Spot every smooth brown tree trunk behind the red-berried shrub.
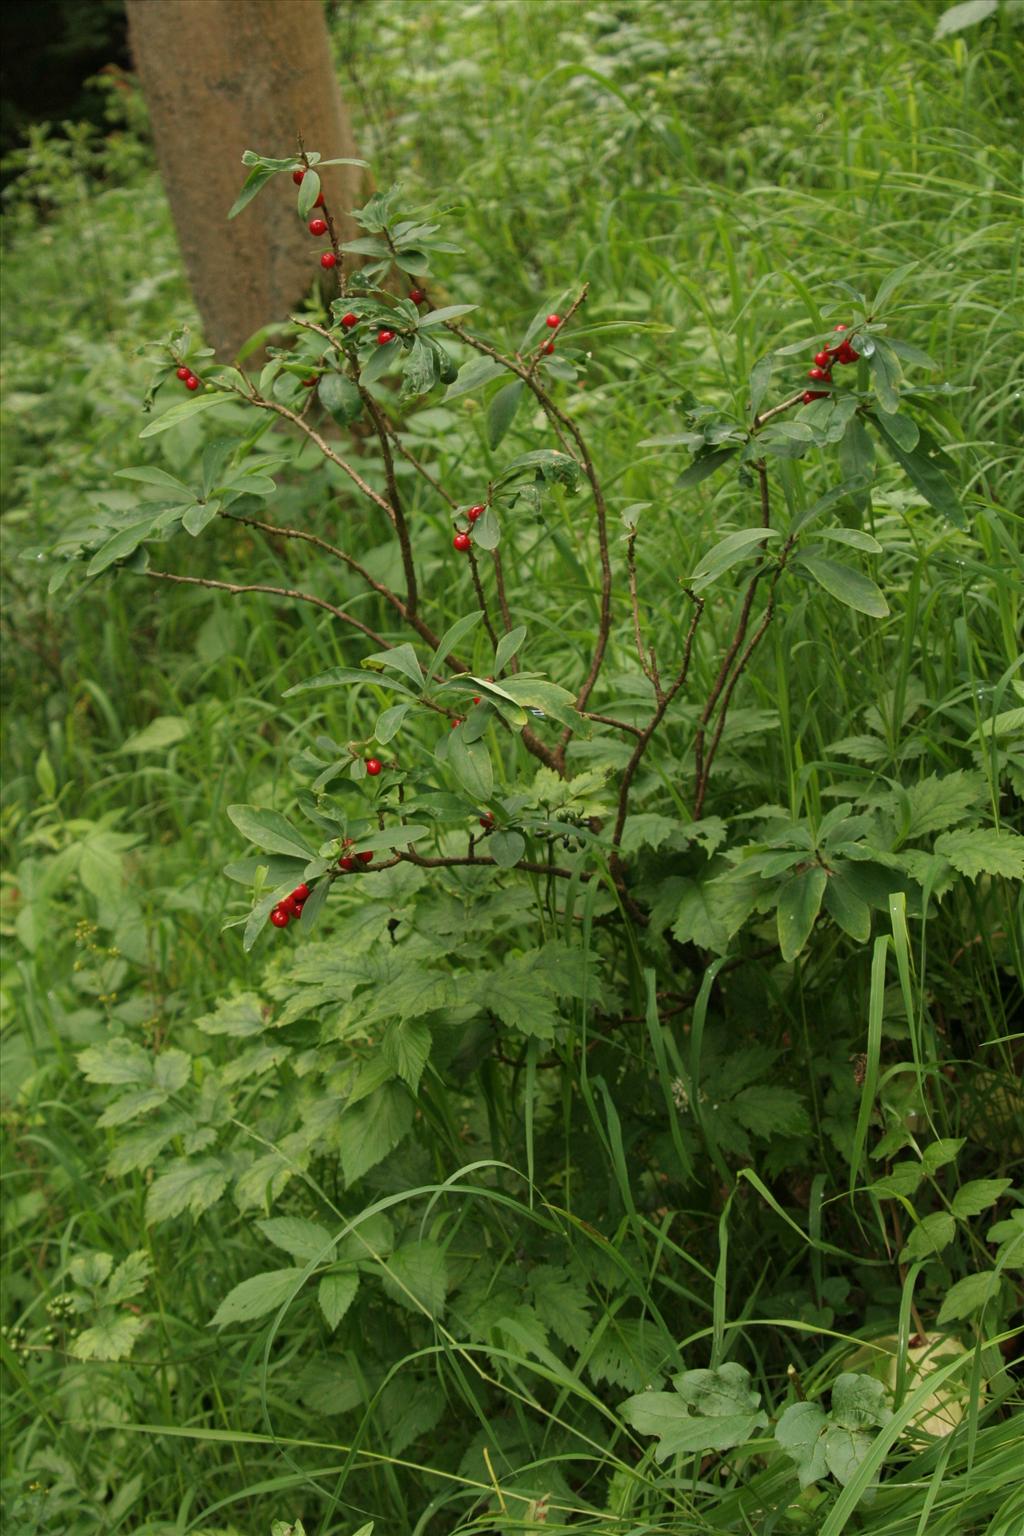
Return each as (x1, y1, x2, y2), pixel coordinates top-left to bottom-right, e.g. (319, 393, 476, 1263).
(127, 0, 364, 361)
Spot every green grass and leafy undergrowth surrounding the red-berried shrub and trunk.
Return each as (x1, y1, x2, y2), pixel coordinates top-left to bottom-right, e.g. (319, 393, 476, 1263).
(0, 0, 1024, 1536)
